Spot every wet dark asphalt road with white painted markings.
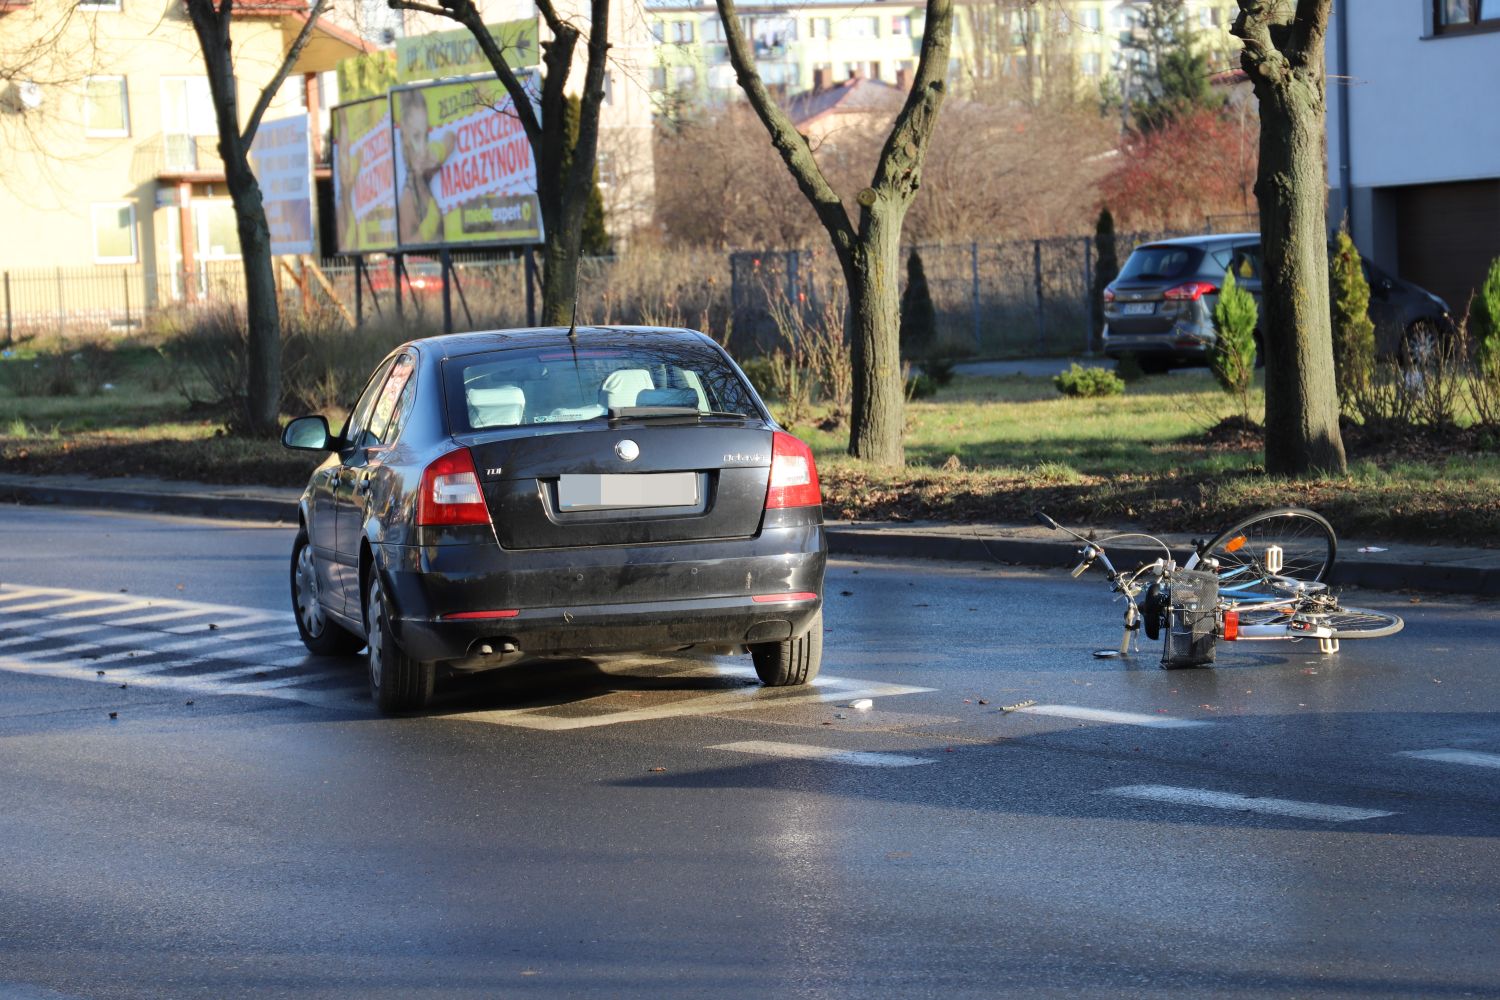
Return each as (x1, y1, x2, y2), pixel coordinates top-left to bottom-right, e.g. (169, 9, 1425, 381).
(0, 507, 1500, 1000)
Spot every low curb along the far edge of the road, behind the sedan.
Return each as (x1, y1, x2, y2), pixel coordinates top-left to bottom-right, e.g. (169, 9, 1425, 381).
(0, 477, 1500, 597)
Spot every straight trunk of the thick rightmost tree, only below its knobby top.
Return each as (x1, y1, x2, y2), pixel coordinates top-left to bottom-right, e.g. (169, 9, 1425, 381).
(1256, 76, 1344, 475)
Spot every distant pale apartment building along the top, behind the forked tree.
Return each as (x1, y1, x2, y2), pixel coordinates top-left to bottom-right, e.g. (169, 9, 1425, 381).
(645, 0, 1236, 115)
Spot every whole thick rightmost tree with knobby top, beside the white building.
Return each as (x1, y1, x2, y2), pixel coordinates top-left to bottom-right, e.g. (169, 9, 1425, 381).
(1233, 0, 1346, 475)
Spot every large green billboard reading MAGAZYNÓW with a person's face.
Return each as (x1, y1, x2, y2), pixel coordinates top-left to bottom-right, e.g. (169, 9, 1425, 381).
(390, 72, 542, 249)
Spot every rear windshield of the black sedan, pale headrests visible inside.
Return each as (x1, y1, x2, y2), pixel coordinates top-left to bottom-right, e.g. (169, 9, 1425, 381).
(444, 340, 761, 433)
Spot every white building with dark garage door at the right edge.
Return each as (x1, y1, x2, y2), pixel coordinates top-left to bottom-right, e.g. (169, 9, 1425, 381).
(1328, 0, 1500, 313)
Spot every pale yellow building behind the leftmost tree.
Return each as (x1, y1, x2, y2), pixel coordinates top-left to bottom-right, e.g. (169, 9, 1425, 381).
(0, 0, 365, 333)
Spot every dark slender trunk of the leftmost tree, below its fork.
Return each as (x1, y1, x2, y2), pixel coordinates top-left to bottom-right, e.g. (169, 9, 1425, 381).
(224, 154, 281, 436)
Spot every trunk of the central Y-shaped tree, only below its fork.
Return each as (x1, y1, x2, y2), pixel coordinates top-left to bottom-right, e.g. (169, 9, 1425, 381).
(843, 202, 906, 466)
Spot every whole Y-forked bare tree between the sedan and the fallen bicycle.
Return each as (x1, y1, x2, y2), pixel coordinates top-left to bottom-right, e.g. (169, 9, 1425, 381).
(717, 0, 953, 466)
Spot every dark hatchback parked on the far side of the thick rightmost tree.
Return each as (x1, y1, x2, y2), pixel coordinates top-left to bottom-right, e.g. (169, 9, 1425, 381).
(1104, 232, 1454, 372)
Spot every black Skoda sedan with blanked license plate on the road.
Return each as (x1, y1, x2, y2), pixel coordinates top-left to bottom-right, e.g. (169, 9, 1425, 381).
(282, 327, 828, 712)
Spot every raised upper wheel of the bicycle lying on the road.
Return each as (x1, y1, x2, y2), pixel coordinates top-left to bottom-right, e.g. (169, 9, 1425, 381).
(1196, 507, 1338, 587)
